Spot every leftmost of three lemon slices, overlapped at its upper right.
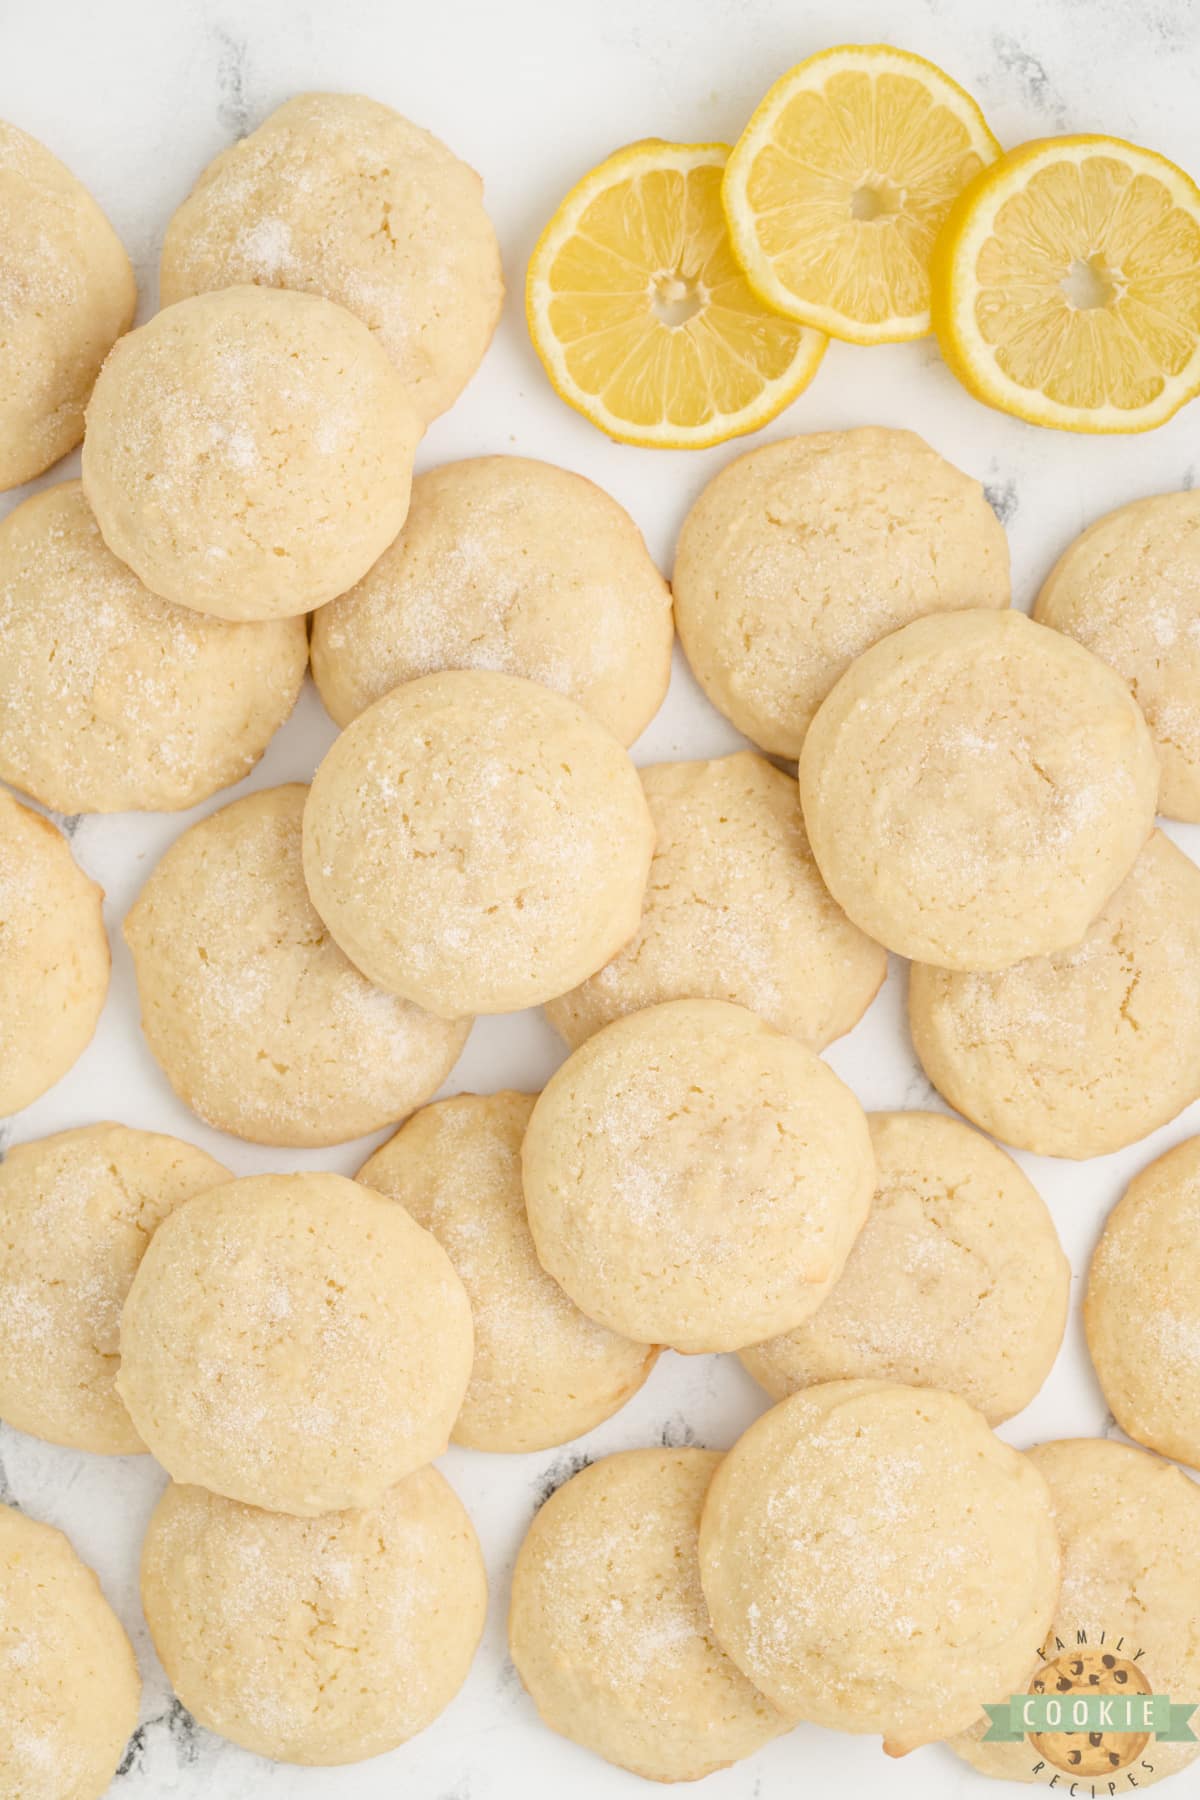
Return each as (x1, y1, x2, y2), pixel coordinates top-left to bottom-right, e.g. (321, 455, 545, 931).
(525, 140, 826, 450)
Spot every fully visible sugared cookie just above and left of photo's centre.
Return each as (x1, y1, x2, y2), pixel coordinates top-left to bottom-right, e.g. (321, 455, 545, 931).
(304, 670, 655, 1019)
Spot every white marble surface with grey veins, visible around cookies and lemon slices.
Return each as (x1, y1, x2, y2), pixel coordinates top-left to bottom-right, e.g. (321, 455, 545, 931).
(0, 0, 1200, 1800)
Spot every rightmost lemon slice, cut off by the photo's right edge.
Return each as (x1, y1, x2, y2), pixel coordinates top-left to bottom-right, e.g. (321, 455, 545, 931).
(934, 137, 1200, 432)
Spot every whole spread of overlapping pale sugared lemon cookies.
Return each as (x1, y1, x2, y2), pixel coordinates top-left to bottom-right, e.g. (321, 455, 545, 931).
(0, 81, 1200, 1800)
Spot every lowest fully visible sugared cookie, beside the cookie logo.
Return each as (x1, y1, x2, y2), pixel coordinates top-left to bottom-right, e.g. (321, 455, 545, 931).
(700, 1381, 1061, 1755)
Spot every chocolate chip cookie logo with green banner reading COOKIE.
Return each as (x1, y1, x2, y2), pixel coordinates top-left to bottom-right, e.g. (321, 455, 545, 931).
(984, 1631, 1198, 1796)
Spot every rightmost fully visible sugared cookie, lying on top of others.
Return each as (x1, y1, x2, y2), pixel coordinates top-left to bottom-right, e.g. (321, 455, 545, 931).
(801, 612, 1159, 968)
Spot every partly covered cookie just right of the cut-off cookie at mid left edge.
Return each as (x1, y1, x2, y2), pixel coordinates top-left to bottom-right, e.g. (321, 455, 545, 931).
(124, 783, 471, 1145)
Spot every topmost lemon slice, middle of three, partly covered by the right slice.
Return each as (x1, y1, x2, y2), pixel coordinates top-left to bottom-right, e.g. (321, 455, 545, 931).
(723, 43, 1000, 344)
